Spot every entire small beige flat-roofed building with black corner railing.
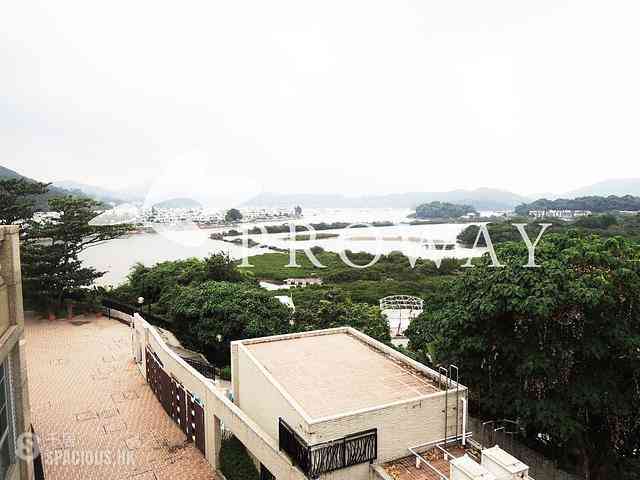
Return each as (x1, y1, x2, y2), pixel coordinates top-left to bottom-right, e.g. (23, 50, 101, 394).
(231, 328, 467, 479)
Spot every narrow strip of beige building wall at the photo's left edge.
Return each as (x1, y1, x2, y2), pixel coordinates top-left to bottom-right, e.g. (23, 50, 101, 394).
(0, 226, 33, 480)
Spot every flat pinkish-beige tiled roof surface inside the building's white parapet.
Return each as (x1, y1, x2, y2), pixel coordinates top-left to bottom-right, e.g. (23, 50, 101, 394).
(245, 332, 439, 420)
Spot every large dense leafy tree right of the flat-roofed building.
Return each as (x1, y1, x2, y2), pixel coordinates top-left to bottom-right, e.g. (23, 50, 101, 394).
(408, 232, 640, 480)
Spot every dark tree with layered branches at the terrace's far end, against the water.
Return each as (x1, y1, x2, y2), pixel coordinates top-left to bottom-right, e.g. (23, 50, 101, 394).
(22, 197, 130, 310)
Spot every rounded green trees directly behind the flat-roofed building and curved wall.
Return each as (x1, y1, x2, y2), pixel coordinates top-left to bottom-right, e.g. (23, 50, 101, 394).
(110, 253, 398, 366)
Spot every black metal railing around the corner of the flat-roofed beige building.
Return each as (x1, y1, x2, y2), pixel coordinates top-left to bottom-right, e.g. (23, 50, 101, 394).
(278, 419, 378, 478)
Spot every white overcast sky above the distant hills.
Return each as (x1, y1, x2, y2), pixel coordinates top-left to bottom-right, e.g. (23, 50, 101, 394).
(0, 0, 640, 194)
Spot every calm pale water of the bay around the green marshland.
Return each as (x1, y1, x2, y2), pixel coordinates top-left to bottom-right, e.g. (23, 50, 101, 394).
(82, 209, 484, 285)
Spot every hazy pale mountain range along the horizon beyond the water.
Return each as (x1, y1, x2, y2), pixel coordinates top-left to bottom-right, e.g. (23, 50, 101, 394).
(0, 163, 640, 211)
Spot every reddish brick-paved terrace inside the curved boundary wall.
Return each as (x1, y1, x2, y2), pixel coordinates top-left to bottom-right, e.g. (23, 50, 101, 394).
(26, 317, 216, 480)
